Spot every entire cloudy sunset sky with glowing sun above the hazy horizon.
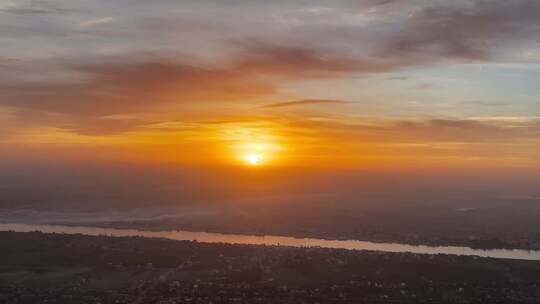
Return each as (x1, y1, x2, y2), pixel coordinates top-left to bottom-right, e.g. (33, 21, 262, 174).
(0, 0, 540, 172)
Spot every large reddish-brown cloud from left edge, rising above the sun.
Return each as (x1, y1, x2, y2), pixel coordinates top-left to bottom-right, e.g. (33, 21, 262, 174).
(0, 43, 400, 115)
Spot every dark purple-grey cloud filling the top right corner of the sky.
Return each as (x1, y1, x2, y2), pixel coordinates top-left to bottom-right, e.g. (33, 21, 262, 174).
(383, 0, 540, 60)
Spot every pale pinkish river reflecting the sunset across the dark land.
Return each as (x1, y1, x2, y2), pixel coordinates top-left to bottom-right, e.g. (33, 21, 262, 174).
(0, 224, 540, 260)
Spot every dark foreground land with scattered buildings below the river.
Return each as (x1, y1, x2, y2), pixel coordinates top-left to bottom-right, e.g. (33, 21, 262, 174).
(0, 232, 540, 304)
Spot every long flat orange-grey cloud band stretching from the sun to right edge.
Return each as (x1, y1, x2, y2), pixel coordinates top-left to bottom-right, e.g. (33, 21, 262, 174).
(287, 117, 540, 144)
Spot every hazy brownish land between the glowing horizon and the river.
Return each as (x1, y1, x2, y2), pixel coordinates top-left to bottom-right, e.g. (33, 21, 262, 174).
(0, 164, 540, 248)
